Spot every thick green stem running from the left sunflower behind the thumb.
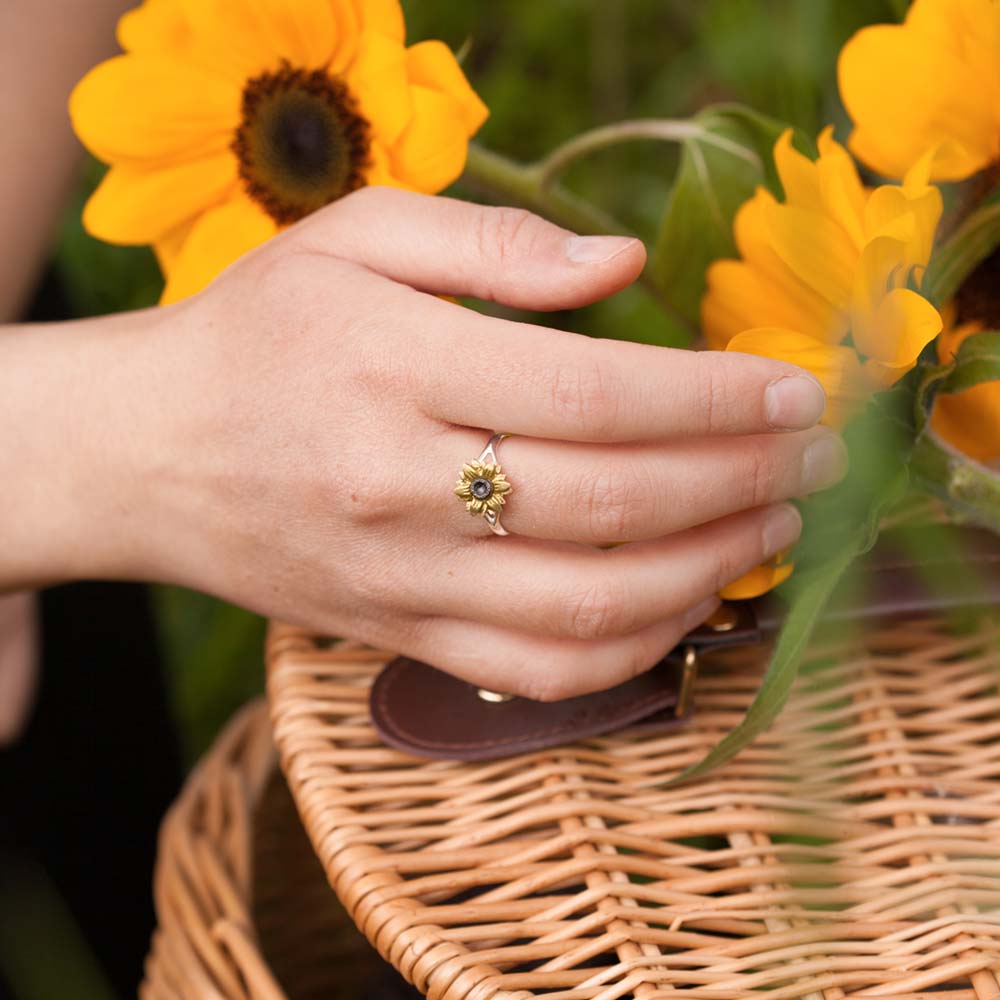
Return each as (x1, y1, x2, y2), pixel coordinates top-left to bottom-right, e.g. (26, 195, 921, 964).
(464, 143, 687, 318)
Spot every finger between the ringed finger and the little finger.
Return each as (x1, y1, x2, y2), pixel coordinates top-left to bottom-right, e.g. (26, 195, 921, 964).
(398, 504, 802, 640)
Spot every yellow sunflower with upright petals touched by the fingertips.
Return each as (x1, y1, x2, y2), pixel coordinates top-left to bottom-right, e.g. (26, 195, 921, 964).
(702, 129, 942, 599)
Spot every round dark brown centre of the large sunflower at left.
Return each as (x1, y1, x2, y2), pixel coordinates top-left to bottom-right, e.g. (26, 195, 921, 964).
(232, 63, 370, 225)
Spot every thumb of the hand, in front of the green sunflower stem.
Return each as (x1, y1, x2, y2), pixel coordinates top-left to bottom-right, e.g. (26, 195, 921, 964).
(296, 187, 646, 309)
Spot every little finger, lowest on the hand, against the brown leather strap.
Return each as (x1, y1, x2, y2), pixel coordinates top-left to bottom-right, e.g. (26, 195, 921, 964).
(406, 600, 719, 701)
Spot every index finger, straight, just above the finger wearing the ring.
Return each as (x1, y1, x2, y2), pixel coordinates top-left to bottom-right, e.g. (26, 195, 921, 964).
(428, 302, 826, 442)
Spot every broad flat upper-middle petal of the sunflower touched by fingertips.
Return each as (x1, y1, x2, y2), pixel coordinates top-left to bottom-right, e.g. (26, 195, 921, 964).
(764, 205, 858, 306)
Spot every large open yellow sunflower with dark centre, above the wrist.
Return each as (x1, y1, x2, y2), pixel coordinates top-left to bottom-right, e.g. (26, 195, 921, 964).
(70, 0, 488, 302)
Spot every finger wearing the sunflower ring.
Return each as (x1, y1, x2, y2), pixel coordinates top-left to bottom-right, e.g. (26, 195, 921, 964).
(446, 427, 847, 545)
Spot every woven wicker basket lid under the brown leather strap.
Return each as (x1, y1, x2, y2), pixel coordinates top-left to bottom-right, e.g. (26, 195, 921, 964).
(269, 621, 1000, 1000)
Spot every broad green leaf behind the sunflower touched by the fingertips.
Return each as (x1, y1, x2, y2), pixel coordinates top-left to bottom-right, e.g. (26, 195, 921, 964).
(652, 105, 808, 324)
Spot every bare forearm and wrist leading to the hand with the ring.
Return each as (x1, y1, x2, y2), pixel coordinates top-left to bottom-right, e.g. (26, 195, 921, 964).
(0, 313, 164, 592)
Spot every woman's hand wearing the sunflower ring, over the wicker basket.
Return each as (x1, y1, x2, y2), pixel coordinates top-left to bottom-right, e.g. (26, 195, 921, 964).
(1, 189, 845, 699)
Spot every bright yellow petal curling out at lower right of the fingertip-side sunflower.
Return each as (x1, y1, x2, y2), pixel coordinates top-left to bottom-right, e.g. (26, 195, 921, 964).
(854, 288, 943, 386)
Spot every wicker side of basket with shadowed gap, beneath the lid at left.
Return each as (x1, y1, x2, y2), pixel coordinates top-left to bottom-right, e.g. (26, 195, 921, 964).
(140, 701, 380, 1000)
